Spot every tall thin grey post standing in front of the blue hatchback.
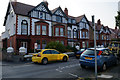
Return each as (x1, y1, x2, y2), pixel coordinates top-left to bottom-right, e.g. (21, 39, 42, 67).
(92, 15, 97, 80)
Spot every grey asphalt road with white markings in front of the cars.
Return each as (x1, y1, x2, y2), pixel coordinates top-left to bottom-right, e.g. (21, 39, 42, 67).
(2, 57, 120, 79)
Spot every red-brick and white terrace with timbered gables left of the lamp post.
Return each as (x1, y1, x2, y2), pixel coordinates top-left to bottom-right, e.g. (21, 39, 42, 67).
(2, 1, 109, 51)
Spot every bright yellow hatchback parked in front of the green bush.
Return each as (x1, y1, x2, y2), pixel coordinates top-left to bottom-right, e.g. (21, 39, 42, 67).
(32, 49, 69, 64)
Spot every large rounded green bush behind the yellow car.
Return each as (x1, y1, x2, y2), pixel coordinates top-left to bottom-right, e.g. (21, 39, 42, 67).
(45, 41, 66, 53)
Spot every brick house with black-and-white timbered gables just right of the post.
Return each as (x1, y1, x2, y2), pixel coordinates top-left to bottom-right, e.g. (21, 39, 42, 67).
(90, 19, 112, 47)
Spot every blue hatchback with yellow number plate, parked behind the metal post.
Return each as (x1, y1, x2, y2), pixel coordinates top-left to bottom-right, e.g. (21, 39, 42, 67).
(80, 48, 118, 71)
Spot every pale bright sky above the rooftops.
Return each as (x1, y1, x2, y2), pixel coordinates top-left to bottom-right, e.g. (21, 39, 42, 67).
(0, 0, 120, 35)
